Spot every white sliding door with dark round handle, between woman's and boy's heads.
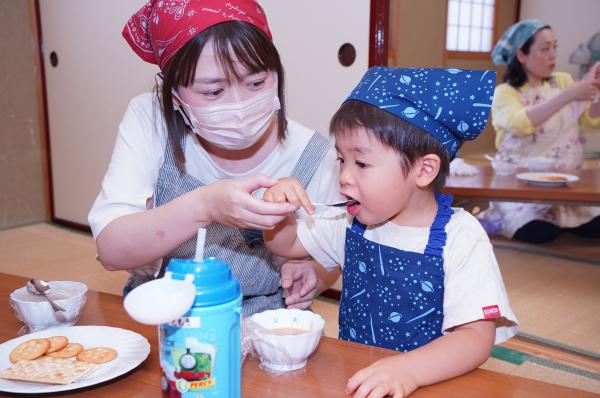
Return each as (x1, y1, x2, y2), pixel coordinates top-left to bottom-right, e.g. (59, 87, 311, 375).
(259, 0, 370, 136)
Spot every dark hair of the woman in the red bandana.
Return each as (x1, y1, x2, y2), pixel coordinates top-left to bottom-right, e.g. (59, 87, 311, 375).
(155, 21, 287, 172)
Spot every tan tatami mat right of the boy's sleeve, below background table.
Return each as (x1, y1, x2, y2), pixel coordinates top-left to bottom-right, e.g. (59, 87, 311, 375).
(495, 238, 600, 353)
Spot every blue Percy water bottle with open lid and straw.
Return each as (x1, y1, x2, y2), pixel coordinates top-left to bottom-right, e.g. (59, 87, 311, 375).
(159, 258, 242, 398)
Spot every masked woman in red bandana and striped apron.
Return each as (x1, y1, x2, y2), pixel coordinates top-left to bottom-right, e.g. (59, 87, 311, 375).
(89, 0, 338, 315)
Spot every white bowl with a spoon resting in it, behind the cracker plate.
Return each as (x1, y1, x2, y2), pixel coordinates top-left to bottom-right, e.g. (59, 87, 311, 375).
(10, 281, 88, 332)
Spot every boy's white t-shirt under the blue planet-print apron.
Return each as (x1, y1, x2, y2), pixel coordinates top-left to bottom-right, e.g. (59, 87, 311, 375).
(298, 208, 518, 344)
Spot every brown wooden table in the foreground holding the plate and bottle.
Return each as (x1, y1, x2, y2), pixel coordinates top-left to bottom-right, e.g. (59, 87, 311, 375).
(0, 273, 598, 398)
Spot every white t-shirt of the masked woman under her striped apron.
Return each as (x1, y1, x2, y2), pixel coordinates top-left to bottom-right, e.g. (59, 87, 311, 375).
(88, 93, 339, 274)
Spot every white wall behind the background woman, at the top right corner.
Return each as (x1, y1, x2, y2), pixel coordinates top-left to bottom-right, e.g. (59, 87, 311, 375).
(520, 0, 600, 151)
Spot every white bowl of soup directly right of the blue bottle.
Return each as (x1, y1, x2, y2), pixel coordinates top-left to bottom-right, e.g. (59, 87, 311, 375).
(250, 308, 325, 372)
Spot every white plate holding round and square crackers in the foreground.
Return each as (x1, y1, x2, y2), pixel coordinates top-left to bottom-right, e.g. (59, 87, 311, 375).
(0, 326, 150, 394)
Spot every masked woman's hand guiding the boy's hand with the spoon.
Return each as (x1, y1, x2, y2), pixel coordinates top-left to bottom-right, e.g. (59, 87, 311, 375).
(198, 174, 296, 230)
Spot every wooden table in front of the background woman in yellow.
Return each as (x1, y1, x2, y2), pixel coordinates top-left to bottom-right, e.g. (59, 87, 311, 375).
(444, 162, 600, 205)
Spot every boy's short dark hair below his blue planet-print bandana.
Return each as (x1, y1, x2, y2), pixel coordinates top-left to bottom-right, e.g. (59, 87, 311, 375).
(329, 101, 450, 190)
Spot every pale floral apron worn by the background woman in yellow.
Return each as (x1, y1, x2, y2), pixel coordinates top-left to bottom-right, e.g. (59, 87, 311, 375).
(486, 79, 600, 238)
